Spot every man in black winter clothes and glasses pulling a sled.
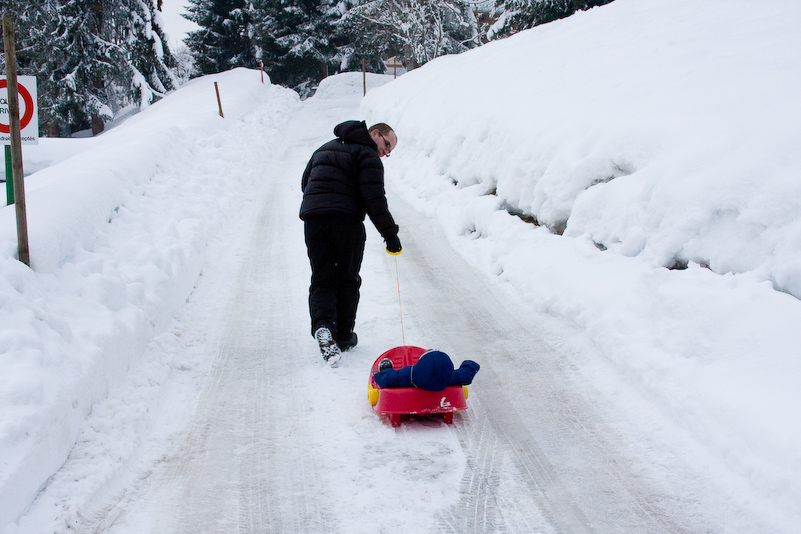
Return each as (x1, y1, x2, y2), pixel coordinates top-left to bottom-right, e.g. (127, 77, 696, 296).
(300, 121, 401, 365)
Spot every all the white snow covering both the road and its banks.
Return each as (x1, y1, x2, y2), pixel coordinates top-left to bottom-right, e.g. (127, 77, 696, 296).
(6, 0, 801, 534)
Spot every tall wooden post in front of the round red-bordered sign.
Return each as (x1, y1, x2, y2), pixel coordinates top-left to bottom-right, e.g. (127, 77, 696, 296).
(3, 16, 31, 267)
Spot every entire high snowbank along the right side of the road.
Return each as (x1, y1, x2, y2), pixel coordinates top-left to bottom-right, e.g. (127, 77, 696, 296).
(362, 0, 801, 528)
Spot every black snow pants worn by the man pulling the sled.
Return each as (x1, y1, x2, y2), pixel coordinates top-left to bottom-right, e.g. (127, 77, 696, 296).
(304, 216, 366, 341)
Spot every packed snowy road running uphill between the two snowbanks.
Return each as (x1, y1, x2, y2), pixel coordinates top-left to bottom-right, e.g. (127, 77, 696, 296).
(101, 90, 682, 533)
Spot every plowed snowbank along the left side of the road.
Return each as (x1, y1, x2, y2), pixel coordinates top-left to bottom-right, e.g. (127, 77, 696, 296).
(0, 69, 298, 526)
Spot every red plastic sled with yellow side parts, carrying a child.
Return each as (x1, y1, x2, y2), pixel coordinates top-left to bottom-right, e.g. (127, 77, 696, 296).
(367, 346, 467, 426)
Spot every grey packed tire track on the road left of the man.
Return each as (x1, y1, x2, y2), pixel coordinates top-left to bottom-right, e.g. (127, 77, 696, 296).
(162, 122, 335, 533)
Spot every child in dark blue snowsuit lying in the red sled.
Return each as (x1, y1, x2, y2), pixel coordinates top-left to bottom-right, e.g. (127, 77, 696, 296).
(373, 350, 481, 391)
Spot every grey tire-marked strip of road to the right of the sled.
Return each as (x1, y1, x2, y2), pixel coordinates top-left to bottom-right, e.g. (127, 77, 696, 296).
(384, 194, 687, 534)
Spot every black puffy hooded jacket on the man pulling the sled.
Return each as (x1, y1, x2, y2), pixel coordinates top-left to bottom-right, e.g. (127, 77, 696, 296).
(300, 121, 398, 239)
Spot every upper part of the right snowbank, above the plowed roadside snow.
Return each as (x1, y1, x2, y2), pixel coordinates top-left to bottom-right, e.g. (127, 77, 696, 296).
(368, 0, 801, 297)
